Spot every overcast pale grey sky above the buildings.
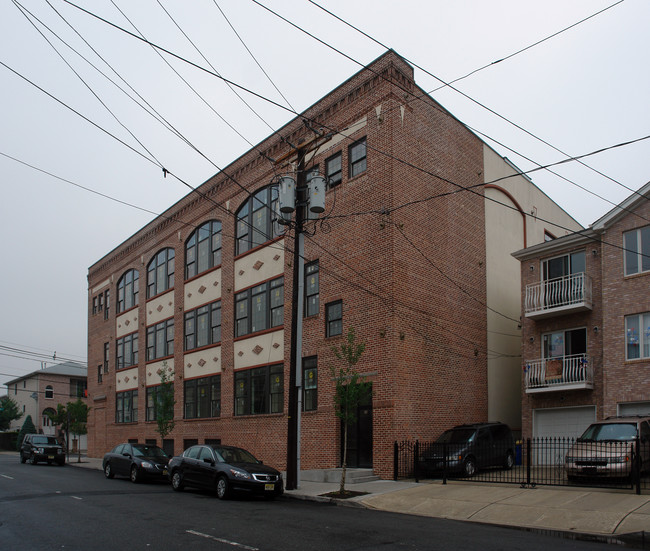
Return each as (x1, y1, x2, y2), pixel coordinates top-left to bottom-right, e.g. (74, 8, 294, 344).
(0, 0, 650, 394)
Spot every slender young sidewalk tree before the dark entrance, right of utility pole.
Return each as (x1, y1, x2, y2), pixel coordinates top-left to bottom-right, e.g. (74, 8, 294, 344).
(332, 327, 372, 496)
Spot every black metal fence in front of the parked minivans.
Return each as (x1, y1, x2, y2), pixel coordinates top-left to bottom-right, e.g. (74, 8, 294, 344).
(393, 438, 650, 493)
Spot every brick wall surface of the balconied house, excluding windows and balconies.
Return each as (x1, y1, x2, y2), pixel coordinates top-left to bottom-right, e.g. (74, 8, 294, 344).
(515, 186, 650, 437)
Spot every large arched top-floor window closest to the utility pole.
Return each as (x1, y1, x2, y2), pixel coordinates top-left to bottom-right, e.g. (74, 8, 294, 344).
(235, 185, 281, 254)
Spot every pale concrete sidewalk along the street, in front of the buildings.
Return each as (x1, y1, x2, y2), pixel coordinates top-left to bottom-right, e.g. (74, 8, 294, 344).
(63, 456, 650, 545)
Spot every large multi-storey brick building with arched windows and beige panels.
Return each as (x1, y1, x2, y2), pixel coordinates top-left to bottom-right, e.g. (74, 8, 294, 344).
(88, 51, 580, 477)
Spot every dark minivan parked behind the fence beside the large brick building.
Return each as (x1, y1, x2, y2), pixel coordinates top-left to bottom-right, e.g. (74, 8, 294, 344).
(420, 423, 515, 477)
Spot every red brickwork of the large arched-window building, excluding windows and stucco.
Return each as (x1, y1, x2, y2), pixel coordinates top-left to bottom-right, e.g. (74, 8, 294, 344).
(88, 52, 512, 477)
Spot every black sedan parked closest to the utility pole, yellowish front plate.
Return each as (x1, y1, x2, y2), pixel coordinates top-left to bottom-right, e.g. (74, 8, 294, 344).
(168, 444, 284, 499)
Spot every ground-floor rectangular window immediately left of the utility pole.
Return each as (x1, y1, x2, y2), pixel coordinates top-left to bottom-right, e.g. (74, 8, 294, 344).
(235, 364, 284, 415)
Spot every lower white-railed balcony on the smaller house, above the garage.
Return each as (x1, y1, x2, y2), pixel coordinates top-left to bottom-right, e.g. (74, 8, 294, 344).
(524, 354, 594, 394)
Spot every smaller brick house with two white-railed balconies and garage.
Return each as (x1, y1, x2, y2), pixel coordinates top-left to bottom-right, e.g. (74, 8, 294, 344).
(514, 184, 650, 437)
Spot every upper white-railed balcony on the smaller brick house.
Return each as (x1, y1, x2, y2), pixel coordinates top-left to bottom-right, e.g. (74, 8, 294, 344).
(524, 272, 593, 319)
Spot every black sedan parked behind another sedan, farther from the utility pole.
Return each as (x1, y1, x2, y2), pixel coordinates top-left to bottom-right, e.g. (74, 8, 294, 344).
(102, 444, 169, 482)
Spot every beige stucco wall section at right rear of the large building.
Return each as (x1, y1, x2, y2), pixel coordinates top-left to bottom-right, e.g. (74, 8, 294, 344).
(484, 146, 581, 429)
